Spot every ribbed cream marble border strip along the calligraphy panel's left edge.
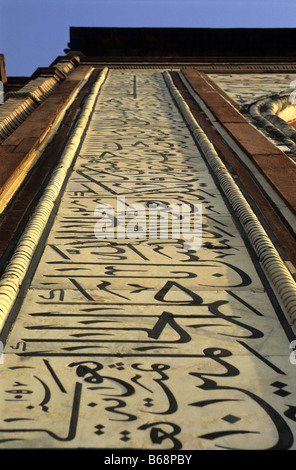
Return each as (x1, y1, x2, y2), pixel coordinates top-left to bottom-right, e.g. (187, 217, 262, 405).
(0, 68, 108, 331)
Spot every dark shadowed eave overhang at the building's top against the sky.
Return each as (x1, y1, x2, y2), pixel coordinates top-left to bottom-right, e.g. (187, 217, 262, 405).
(67, 27, 296, 63)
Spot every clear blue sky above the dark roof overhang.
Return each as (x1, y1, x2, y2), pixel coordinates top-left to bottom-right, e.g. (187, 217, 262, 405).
(0, 0, 296, 76)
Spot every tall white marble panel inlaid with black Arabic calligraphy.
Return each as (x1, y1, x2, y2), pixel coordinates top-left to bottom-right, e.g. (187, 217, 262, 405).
(0, 69, 296, 450)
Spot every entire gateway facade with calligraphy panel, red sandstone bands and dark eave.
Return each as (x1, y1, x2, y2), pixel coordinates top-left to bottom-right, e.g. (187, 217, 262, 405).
(0, 28, 296, 451)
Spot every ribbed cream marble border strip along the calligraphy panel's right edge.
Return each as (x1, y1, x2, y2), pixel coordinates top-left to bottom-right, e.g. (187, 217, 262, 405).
(164, 72, 296, 327)
